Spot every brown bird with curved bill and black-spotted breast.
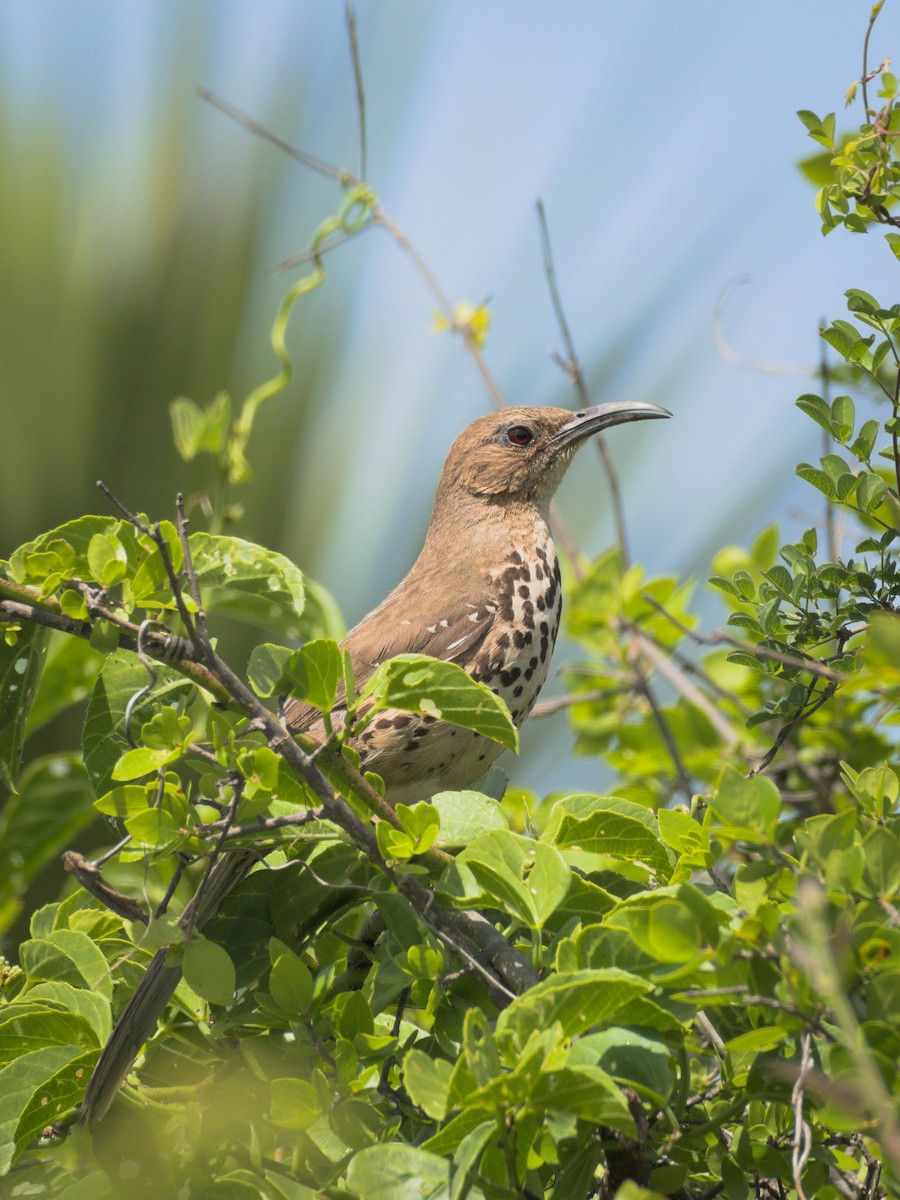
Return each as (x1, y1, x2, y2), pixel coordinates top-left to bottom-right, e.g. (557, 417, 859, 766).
(79, 401, 671, 1126)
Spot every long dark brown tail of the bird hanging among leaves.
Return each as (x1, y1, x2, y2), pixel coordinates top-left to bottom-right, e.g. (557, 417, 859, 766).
(78, 851, 259, 1126)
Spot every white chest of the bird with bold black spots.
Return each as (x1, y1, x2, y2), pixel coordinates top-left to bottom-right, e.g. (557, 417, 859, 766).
(469, 539, 563, 725)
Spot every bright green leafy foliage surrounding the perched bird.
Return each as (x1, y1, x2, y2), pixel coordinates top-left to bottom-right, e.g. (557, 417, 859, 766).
(0, 5, 900, 1200)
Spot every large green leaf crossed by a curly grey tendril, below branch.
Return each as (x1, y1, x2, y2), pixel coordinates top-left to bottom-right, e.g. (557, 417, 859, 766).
(82, 650, 194, 796)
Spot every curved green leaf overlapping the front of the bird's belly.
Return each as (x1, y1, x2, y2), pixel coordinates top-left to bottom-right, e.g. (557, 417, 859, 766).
(362, 654, 518, 751)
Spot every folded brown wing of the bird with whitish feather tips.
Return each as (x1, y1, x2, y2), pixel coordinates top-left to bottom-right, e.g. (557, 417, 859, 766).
(284, 596, 497, 734)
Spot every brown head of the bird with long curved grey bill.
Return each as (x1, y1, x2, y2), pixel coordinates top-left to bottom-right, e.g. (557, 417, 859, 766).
(436, 401, 671, 511)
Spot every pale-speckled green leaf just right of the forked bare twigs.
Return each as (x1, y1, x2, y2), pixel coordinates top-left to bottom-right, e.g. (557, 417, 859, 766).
(188, 533, 304, 637)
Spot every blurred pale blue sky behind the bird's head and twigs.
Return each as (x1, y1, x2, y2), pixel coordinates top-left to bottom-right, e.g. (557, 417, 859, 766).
(0, 7, 899, 796)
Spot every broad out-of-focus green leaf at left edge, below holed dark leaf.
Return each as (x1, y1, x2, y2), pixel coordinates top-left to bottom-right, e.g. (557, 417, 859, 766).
(0, 754, 94, 931)
